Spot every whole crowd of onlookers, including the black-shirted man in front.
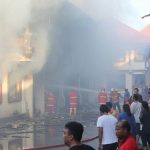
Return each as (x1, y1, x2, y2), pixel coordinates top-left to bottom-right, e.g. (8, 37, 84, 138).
(63, 88, 150, 150)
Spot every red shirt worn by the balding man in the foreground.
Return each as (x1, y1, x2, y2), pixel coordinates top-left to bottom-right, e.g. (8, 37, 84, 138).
(119, 135, 138, 150)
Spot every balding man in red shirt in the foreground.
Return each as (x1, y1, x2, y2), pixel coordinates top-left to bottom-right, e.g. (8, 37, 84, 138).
(116, 120, 138, 150)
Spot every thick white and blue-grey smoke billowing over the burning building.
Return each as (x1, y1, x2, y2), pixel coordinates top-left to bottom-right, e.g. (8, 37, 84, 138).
(0, 0, 149, 89)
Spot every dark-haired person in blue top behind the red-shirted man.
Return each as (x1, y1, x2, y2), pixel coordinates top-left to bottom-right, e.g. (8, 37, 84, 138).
(118, 104, 136, 137)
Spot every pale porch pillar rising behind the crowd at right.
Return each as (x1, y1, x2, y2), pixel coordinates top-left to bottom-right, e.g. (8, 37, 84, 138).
(125, 73, 133, 93)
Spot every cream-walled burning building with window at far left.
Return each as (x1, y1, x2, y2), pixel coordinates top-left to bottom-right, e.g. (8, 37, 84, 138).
(0, 27, 33, 118)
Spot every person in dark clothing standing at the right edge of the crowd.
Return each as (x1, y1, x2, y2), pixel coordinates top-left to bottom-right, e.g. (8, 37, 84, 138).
(140, 101, 150, 150)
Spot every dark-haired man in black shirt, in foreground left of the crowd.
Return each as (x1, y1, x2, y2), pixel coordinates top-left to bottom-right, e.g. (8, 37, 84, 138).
(63, 121, 95, 150)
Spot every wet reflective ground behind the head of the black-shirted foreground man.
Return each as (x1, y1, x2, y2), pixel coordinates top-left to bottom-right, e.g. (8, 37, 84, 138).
(0, 116, 97, 150)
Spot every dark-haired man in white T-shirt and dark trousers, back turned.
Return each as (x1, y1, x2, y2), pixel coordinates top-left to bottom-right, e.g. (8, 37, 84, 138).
(97, 105, 118, 150)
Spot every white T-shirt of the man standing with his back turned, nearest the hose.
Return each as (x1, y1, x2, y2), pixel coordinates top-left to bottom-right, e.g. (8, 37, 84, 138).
(97, 115, 117, 145)
